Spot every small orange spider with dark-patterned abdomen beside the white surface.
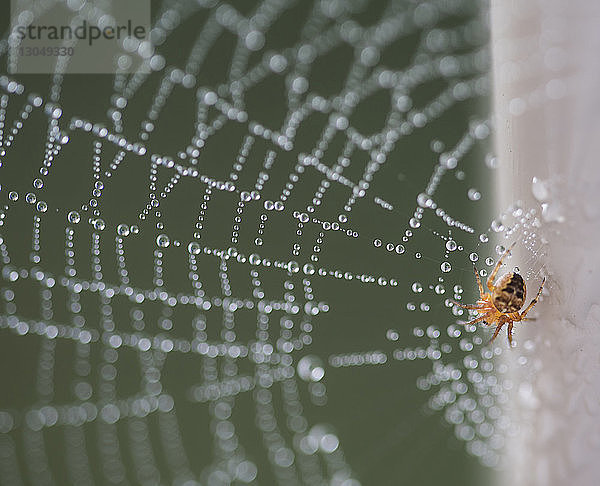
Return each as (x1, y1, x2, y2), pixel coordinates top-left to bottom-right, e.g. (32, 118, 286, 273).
(454, 242, 546, 346)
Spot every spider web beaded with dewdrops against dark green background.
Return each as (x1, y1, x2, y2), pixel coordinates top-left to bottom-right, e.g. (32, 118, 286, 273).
(0, 0, 536, 486)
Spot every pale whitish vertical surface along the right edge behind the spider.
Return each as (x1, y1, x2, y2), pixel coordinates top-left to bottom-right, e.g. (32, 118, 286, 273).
(492, 0, 600, 486)
